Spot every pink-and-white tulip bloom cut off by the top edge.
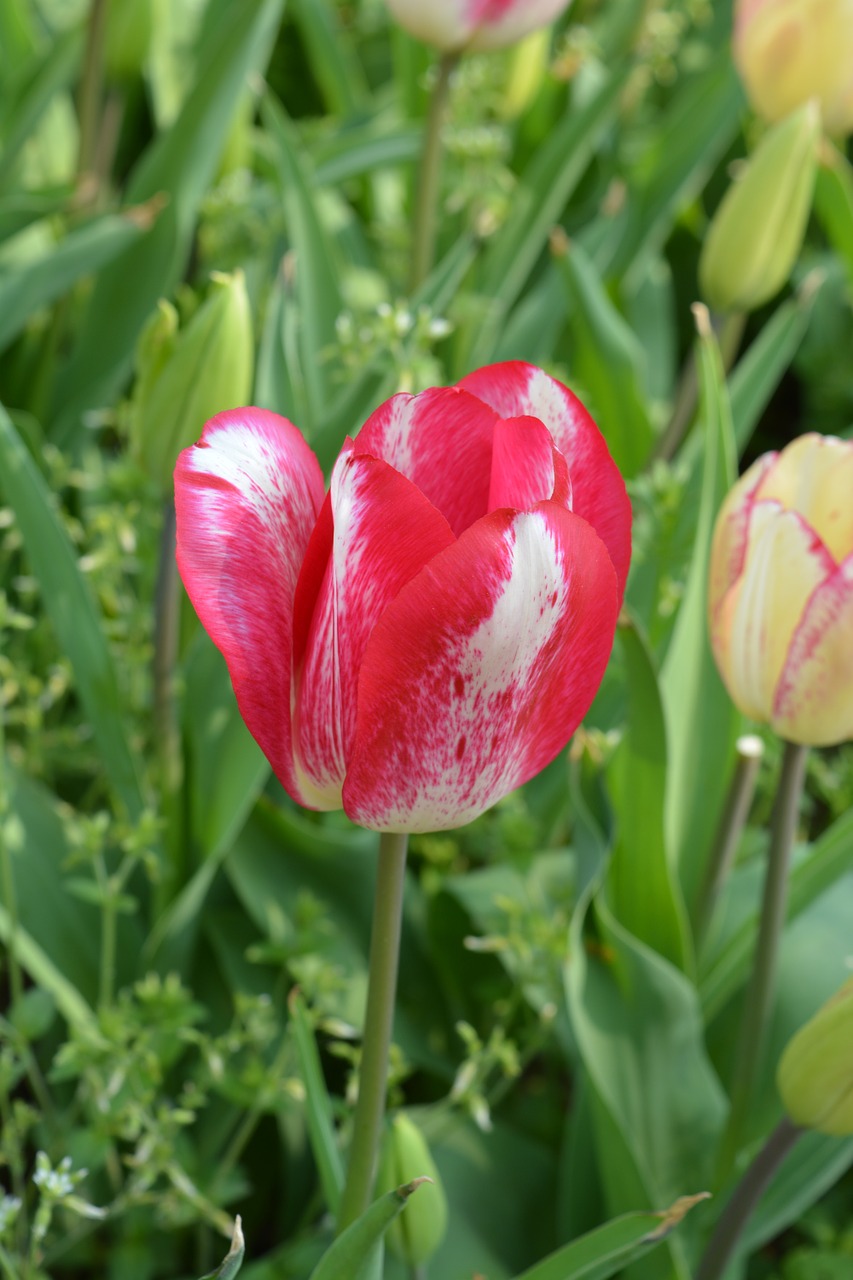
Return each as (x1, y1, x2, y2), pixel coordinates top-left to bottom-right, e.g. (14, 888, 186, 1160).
(388, 0, 570, 52)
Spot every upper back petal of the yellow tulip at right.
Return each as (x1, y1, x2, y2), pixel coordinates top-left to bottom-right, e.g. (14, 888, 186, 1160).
(756, 431, 853, 563)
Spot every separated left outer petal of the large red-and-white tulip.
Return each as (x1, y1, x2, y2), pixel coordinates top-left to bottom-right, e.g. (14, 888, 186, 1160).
(174, 408, 323, 800)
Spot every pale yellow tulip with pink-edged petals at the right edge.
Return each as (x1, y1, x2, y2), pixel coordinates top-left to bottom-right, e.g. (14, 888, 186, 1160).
(710, 434, 853, 746)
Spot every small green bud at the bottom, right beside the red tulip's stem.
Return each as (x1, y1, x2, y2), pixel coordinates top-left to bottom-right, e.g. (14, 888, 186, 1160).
(375, 1112, 447, 1267)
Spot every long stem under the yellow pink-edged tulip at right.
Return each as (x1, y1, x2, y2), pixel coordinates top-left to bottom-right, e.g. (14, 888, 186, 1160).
(719, 742, 808, 1183)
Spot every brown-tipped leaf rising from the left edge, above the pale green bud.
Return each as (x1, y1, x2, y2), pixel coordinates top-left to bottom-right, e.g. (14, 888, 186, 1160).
(0, 209, 151, 351)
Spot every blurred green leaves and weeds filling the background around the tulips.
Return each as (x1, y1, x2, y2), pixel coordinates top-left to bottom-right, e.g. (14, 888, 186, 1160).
(0, 0, 853, 1280)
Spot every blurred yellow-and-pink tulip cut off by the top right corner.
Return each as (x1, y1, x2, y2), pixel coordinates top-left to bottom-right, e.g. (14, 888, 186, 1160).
(734, 0, 853, 133)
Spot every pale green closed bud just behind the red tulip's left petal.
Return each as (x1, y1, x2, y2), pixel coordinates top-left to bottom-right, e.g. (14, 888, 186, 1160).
(131, 271, 254, 489)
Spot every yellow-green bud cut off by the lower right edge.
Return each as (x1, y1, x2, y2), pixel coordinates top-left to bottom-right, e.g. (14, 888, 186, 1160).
(776, 978, 853, 1138)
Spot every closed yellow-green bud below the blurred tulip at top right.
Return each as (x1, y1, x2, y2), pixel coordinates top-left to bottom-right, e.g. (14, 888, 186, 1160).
(699, 102, 821, 312)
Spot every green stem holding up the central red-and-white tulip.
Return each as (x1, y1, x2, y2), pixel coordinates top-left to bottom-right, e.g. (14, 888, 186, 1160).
(338, 832, 409, 1231)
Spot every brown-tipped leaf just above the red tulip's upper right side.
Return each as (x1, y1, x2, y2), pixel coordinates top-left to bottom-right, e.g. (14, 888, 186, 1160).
(556, 242, 652, 477)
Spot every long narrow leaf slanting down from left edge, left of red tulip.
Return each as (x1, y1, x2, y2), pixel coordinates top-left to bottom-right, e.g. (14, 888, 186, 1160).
(0, 407, 142, 818)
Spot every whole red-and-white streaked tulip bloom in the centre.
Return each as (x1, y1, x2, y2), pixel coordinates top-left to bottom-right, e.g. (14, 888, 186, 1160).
(175, 362, 630, 832)
